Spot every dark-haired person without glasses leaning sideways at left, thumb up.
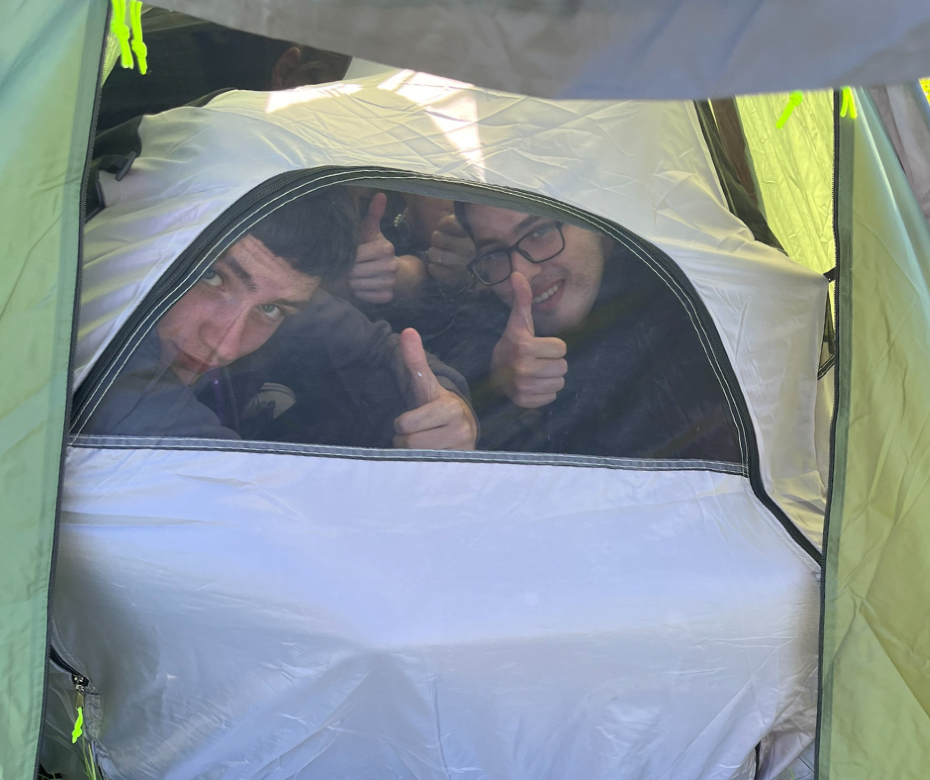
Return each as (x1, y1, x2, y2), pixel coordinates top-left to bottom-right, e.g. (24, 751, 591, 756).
(84, 189, 477, 449)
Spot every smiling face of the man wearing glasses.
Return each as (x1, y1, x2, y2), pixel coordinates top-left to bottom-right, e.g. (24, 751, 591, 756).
(467, 204, 606, 336)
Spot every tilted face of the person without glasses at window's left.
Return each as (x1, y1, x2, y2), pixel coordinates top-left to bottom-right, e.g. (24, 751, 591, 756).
(155, 235, 320, 385)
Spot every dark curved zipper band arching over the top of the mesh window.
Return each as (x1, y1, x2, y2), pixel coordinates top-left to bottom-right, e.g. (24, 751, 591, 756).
(73, 166, 821, 564)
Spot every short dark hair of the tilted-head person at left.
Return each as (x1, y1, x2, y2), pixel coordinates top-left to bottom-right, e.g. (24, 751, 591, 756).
(249, 187, 355, 280)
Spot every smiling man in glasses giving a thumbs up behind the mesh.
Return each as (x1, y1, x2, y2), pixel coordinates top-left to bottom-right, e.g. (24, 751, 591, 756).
(440, 203, 741, 462)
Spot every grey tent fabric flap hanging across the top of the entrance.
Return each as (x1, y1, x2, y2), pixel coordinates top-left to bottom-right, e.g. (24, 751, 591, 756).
(152, 0, 930, 99)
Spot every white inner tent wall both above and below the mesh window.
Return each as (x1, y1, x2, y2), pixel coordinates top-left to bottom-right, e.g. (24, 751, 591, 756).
(50, 71, 826, 780)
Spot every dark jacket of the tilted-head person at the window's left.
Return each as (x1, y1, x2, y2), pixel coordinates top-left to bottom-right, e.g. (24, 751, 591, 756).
(82, 290, 468, 447)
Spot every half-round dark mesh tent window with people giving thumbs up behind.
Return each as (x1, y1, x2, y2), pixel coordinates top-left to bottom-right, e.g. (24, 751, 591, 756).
(80, 180, 744, 464)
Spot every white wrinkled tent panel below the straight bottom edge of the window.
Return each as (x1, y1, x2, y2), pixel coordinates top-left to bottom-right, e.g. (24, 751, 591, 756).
(53, 447, 818, 780)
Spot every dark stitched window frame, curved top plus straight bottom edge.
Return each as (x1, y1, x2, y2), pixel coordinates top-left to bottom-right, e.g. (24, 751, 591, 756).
(69, 167, 821, 563)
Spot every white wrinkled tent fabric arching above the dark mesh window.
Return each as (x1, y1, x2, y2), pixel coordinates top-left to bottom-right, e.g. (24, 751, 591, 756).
(75, 71, 827, 542)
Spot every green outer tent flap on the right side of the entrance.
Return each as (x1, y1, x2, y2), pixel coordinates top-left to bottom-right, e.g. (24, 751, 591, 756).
(819, 90, 930, 780)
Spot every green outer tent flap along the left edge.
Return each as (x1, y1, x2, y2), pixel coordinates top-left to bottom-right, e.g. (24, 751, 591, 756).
(0, 0, 106, 780)
